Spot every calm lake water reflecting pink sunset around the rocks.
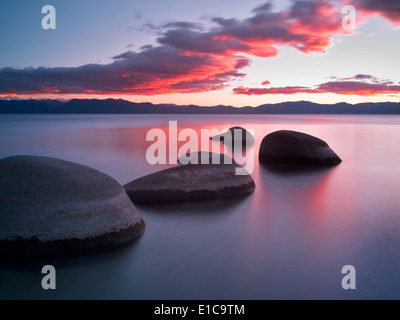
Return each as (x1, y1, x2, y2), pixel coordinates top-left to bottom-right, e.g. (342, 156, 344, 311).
(0, 115, 400, 299)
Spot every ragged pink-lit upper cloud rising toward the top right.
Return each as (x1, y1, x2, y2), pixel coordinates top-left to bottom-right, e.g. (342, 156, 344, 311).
(158, 0, 343, 57)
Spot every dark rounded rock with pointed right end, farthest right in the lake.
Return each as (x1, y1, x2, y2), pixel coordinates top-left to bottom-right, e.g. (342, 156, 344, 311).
(259, 130, 342, 166)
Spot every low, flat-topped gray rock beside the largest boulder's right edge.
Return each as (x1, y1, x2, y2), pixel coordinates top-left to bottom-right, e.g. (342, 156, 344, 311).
(124, 164, 255, 205)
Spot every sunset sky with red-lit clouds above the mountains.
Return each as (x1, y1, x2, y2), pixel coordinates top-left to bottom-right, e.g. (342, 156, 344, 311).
(0, 0, 400, 107)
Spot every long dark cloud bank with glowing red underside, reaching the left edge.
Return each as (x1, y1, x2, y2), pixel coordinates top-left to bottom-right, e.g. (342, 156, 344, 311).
(0, 46, 250, 95)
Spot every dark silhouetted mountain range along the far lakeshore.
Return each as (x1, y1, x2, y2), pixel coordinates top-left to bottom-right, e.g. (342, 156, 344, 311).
(0, 99, 400, 114)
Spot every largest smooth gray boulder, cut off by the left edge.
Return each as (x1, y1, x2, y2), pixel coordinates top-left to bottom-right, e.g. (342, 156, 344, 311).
(0, 156, 145, 254)
